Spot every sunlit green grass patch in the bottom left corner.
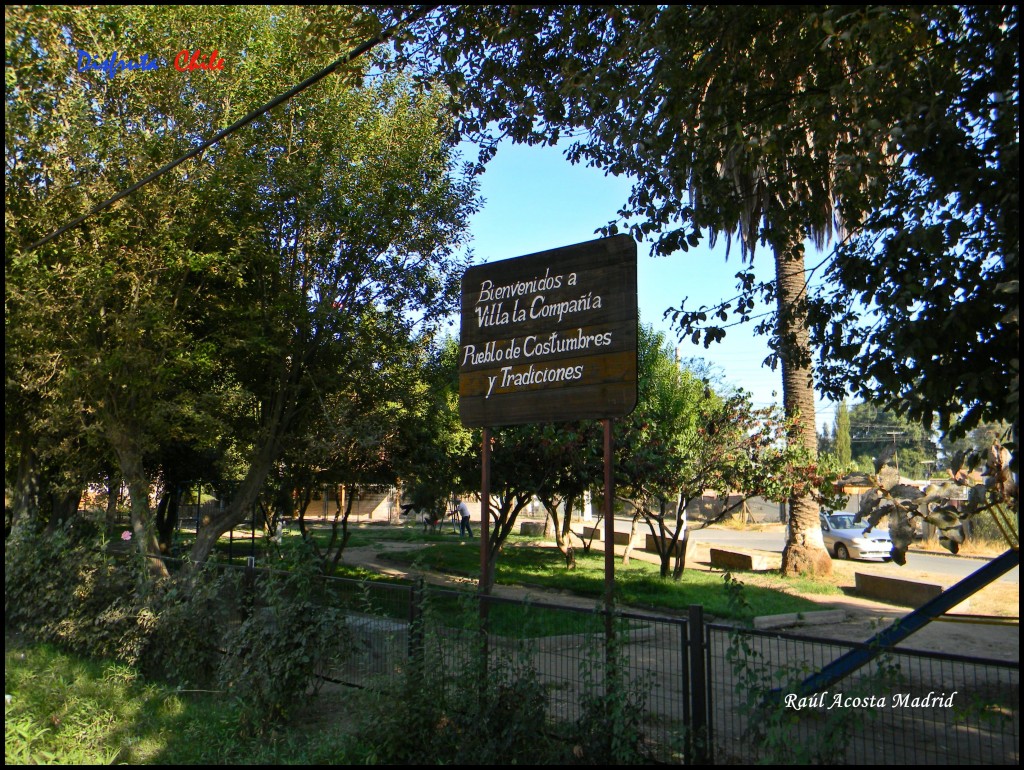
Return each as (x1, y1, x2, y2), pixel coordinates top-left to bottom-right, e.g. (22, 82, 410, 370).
(4, 634, 356, 765)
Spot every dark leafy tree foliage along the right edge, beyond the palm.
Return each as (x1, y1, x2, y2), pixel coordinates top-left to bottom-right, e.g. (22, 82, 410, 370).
(812, 5, 1020, 450)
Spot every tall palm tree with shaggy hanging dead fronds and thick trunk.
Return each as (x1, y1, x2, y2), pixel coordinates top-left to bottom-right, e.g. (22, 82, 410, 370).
(605, 6, 913, 574)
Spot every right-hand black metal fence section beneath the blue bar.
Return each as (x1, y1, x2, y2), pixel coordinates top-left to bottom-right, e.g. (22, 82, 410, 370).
(705, 625, 1020, 765)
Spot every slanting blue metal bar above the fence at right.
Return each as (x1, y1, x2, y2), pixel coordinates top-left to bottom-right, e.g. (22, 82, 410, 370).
(773, 551, 1020, 695)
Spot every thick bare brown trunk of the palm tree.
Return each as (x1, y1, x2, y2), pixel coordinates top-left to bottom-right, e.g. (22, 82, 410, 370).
(775, 240, 831, 575)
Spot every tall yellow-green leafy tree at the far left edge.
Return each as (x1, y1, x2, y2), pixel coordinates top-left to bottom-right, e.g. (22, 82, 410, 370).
(5, 7, 258, 568)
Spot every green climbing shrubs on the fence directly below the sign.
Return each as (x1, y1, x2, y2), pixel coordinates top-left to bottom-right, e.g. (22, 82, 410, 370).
(357, 599, 648, 766)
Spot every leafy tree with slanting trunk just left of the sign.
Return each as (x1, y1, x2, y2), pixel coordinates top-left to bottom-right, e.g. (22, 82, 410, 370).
(186, 67, 472, 560)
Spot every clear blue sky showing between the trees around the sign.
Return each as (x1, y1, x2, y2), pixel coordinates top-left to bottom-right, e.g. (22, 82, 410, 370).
(464, 144, 835, 434)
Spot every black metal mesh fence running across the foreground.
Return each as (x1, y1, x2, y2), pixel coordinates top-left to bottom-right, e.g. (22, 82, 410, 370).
(211, 569, 1020, 765)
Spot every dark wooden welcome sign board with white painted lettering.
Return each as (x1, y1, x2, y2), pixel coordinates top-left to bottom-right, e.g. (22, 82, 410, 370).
(459, 236, 637, 427)
